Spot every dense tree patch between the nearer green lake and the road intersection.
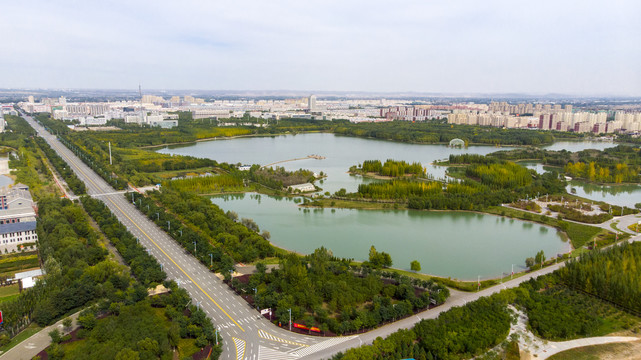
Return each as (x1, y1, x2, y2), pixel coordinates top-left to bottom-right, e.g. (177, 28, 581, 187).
(232, 248, 449, 334)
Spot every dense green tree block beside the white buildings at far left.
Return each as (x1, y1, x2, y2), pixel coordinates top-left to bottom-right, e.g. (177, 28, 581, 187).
(0, 197, 110, 335)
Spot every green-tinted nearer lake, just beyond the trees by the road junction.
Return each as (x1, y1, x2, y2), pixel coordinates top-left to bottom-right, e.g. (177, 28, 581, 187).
(211, 194, 569, 280)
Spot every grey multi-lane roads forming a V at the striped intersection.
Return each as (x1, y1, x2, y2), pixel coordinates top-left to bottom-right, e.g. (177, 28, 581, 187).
(23, 115, 639, 360)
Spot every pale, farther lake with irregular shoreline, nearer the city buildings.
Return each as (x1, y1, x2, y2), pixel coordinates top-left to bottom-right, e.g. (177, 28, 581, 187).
(158, 133, 510, 193)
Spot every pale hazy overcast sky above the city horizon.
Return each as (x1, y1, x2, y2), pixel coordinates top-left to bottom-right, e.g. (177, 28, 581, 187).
(0, 0, 641, 95)
